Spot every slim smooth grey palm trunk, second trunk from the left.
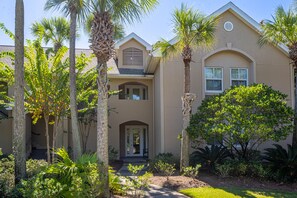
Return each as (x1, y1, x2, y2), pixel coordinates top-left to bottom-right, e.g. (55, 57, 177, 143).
(69, 11, 82, 160)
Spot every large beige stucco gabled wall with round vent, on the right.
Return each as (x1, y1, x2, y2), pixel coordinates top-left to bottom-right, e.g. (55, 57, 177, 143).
(163, 11, 292, 155)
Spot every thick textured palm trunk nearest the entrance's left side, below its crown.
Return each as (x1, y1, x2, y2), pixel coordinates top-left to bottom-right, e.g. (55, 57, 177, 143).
(97, 61, 109, 197)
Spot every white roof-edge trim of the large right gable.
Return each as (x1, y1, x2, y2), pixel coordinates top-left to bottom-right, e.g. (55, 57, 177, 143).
(154, 1, 289, 57)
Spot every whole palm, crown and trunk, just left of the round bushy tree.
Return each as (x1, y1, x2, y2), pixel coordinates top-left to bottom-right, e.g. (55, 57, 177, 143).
(155, 4, 216, 169)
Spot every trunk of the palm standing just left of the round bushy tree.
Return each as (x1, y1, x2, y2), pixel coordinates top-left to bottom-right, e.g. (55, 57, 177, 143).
(180, 46, 196, 171)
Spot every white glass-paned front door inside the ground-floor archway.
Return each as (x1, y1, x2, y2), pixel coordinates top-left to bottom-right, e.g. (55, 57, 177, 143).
(125, 126, 146, 157)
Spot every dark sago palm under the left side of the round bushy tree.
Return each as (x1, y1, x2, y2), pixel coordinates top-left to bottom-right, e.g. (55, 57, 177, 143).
(190, 145, 230, 170)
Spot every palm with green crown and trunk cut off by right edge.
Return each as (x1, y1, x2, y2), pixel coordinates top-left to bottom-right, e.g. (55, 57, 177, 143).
(259, 6, 297, 145)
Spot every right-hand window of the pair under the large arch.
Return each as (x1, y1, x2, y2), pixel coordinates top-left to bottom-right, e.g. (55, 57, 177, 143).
(231, 68, 248, 86)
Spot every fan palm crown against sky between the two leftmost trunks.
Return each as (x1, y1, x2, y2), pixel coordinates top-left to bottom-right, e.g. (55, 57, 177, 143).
(31, 17, 70, 53)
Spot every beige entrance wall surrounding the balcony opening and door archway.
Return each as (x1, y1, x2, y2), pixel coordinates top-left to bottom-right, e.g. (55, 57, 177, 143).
(82, 78, 154, 156)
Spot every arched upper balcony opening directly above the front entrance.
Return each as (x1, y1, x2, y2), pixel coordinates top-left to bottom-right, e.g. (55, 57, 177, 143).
(119, 83, 148, 100)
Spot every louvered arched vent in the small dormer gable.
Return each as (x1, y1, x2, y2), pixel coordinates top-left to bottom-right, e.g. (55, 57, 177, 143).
(123, 47, 143, 66)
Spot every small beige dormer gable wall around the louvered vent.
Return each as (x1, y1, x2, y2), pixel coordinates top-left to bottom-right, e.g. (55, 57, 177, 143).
(117, 39, 149, 69)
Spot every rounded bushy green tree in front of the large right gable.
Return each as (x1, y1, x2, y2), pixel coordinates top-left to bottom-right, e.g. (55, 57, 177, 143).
(187, 84, 294, 159)
